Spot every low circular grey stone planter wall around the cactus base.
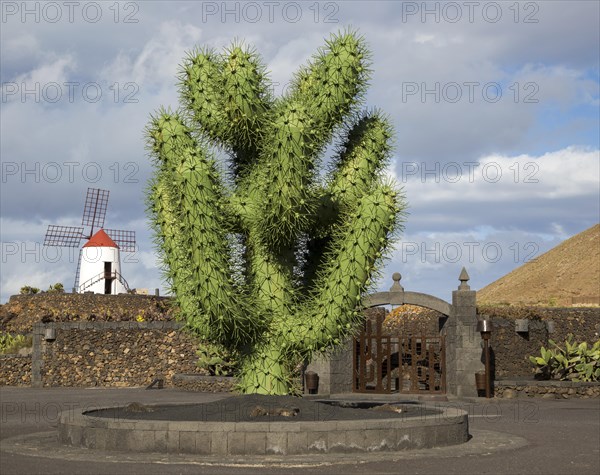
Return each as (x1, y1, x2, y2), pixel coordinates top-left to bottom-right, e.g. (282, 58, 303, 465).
(58, 398, 469, 456)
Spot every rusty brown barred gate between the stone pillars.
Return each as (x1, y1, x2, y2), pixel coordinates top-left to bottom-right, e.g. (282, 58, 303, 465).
(353, 315, 446, 394)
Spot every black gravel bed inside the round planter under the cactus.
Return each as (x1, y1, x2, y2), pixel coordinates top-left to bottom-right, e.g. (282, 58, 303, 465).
(84, 394, 440, 422)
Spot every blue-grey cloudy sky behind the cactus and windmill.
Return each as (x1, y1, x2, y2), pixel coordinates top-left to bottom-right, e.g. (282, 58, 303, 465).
(0, 1, 600, 302)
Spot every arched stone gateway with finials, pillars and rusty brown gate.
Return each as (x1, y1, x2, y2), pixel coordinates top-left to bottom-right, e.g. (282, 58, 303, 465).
(307, 268, 484, 396)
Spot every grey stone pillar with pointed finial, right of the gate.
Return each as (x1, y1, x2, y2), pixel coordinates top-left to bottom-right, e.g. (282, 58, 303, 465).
(444, 267, 484, 397)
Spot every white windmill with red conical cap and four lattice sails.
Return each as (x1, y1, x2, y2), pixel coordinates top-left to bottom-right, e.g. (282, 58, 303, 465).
(44, 188, 136, 294)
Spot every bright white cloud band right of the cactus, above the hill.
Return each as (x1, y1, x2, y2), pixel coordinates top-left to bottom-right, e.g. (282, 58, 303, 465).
(394, 147, 600, 206)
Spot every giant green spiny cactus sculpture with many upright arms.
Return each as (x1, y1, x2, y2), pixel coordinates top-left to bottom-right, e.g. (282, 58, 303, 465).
(147, 28, 403, 394)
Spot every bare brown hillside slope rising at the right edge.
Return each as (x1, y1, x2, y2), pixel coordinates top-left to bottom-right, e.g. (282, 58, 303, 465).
(477, 224, 600, 307)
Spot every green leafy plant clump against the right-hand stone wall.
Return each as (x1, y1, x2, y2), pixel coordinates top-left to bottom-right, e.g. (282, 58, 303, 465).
(529, 333, 600, 381)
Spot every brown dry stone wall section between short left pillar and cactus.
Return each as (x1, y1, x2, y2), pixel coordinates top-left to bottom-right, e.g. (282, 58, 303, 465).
(34, 322, 202, 387)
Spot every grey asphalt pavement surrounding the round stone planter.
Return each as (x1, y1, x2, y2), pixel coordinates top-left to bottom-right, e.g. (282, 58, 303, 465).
(0, 387, 600, 475)
